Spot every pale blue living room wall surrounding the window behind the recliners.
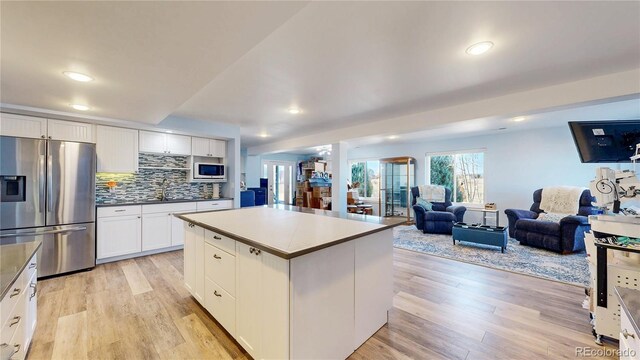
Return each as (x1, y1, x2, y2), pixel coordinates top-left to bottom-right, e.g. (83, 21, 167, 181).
(348, 126, 630, 224)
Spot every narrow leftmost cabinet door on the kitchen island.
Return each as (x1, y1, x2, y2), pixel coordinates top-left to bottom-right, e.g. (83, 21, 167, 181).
(183, 222, 204, 302)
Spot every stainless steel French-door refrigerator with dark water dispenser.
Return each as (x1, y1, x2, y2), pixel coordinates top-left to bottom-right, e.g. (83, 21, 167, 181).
(0, 136, 96, 277)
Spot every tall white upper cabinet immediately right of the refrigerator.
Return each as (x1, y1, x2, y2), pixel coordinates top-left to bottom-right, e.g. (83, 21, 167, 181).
(96, 125, 138, 173)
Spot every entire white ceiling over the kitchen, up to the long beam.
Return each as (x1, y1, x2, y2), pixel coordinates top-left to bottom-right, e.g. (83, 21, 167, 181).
(0, 2, 640, 147)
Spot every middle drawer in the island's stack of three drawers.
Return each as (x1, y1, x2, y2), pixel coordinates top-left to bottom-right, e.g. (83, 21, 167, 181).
(204, 244, 236, 296)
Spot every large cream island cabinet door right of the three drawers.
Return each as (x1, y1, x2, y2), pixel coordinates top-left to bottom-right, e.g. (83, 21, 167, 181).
(236, 242, 289, 359)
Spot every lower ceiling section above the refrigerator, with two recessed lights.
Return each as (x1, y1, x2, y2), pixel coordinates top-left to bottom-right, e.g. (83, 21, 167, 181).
(0, 1, 306, 124)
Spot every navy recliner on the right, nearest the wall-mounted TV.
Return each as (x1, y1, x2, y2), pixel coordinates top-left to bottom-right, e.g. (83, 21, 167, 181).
(504, 189, 595, 254)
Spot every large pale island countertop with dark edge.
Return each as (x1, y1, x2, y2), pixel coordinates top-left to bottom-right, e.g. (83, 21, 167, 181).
(175, 206, 406, 259)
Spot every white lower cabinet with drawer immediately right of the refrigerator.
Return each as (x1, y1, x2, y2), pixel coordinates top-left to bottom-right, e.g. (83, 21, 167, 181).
(97, 206, 142, 259)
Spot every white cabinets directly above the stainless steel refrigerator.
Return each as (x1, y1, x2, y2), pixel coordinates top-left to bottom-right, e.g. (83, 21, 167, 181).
(0, 113, 96, 143)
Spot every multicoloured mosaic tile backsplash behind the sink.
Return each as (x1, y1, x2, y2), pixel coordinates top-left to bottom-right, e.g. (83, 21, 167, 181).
(96, 154, 224, 204)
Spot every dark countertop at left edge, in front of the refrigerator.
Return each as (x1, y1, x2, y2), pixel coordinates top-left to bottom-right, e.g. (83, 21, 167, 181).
(0, 241, 42, 299)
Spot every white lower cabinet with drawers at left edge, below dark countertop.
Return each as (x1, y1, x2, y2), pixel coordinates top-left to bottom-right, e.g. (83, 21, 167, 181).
(0, 255, 38, 360)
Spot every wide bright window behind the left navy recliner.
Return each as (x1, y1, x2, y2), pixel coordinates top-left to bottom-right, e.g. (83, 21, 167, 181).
(426, 151, 484, 204)
